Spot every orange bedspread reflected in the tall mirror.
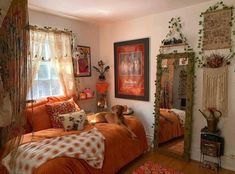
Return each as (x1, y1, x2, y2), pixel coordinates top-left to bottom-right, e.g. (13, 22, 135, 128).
(158, 109, 184, 143)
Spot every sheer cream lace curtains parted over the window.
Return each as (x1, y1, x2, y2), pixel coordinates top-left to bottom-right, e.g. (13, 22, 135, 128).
(28, 27, 77, 98)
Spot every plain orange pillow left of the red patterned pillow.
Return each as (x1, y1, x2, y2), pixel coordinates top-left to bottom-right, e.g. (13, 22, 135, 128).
(26, 104, 52, 131)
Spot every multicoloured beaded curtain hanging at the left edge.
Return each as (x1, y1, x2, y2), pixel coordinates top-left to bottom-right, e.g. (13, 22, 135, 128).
(0, 0, 28, 163)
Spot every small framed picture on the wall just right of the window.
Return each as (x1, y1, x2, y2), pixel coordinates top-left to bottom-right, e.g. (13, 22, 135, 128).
(73, 45, 91, 77)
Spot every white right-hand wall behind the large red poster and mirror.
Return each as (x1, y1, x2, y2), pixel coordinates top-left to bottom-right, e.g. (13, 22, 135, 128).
(99, 0, 235, 170)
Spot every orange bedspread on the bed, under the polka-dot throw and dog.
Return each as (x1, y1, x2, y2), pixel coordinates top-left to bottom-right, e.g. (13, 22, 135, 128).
(0, 116, 147, 174)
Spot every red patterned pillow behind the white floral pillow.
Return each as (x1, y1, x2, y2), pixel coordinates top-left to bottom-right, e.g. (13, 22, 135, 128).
(45, 101, 77, 128)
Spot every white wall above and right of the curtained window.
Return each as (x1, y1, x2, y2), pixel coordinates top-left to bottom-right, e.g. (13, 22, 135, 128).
(29, 10, 99, 111)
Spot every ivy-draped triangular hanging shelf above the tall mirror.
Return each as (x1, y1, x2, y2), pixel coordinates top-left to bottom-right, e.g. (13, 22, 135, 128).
(159, 17, 192, 53)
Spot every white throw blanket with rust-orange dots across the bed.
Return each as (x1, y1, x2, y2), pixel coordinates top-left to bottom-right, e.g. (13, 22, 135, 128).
(3, 128, 105, 174)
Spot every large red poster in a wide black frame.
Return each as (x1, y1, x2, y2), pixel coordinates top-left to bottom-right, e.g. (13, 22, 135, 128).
(114, 38, 149, 101)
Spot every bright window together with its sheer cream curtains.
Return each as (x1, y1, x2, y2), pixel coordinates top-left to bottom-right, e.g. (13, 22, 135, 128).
(28, 27, 77, 100)
